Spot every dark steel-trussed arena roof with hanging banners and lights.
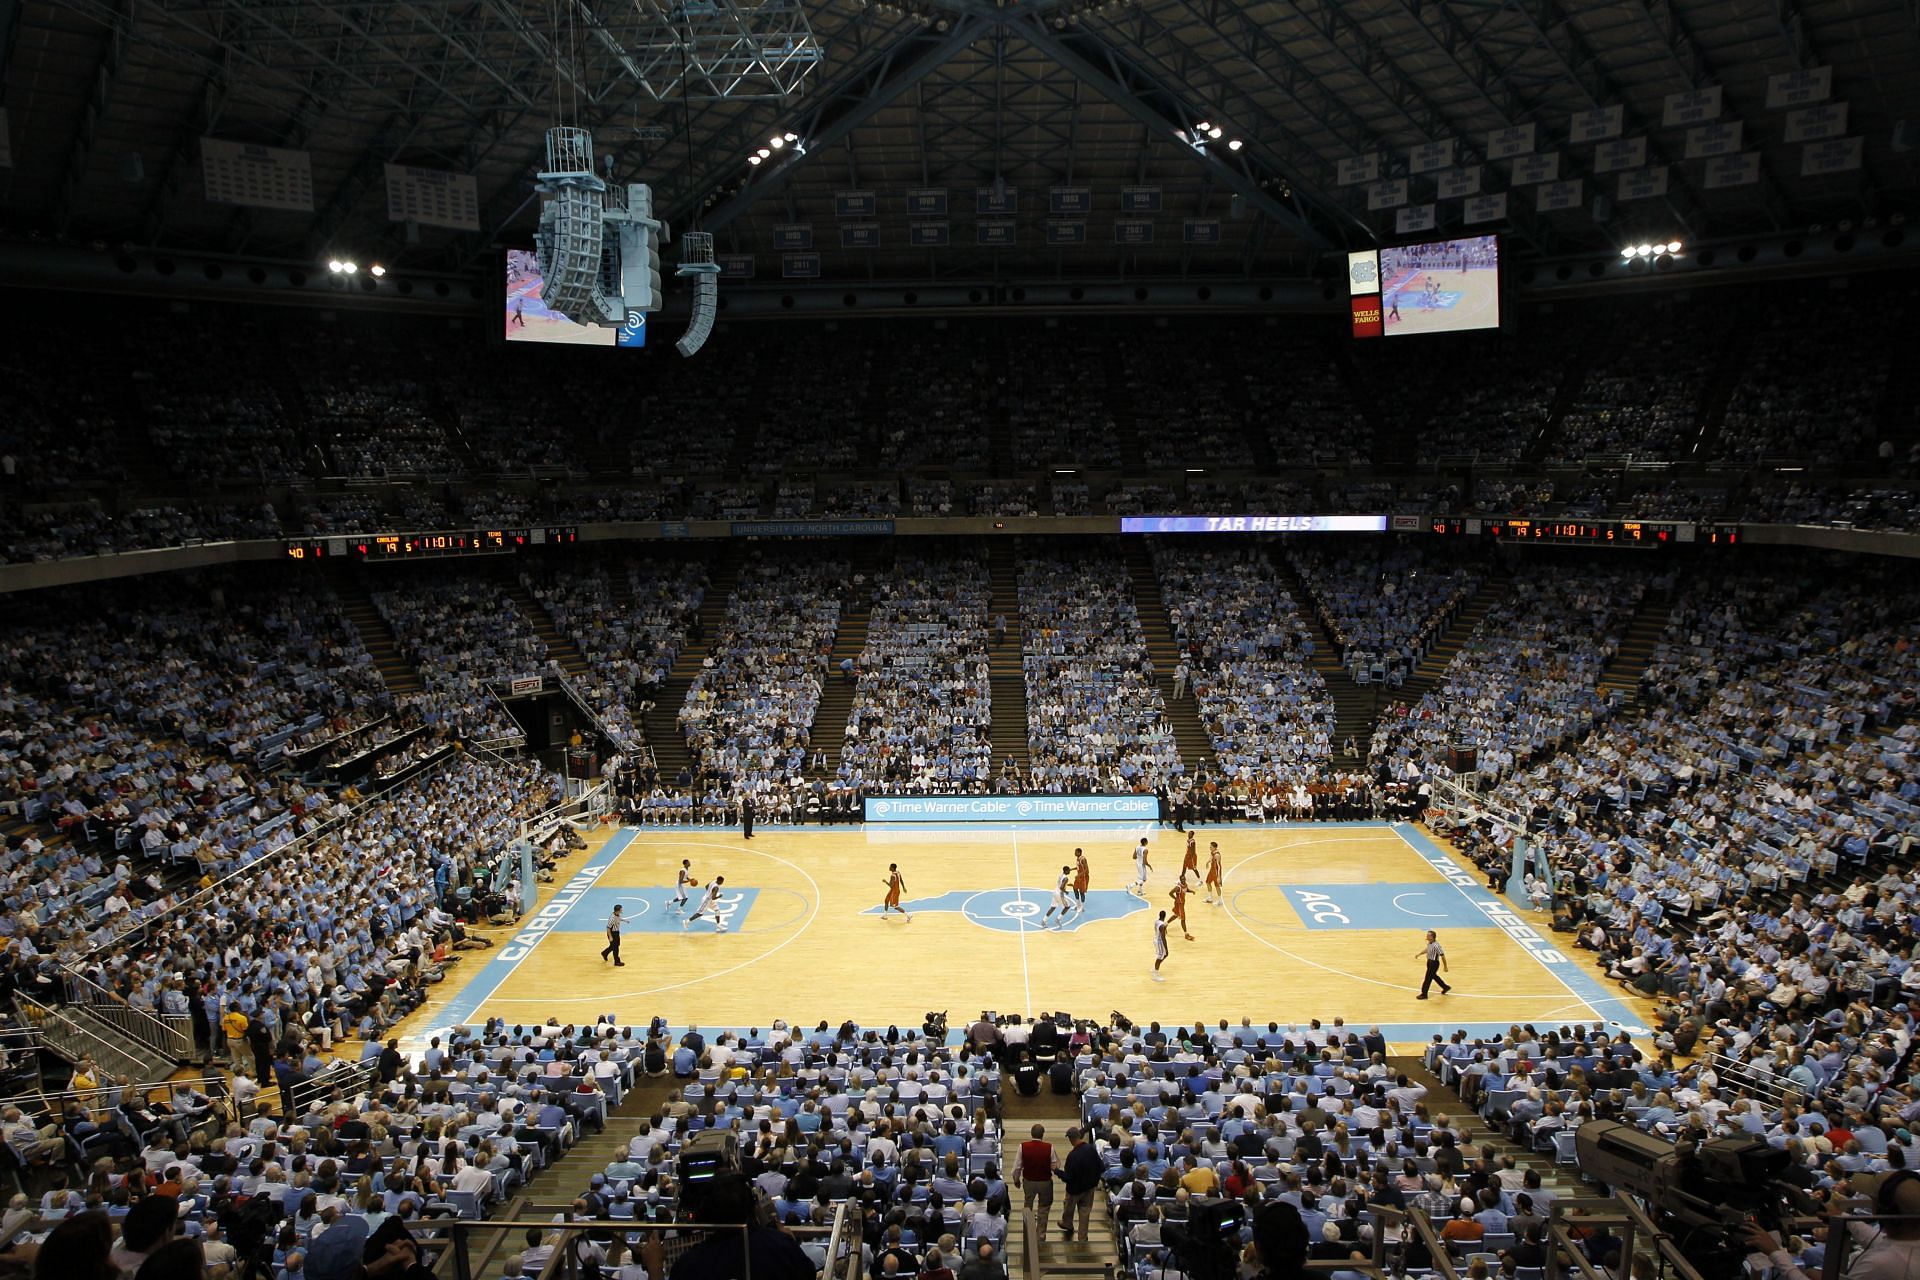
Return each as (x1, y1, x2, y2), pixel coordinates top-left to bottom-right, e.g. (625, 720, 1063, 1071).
(0, 0, 1920, 289)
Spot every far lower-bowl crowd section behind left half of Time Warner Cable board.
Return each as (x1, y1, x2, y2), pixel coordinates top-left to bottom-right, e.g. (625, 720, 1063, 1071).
(835, 553, 993, 793)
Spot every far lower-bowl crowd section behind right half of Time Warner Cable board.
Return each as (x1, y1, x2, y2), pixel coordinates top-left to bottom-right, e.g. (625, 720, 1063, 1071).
(1020, 549, 1183, 793)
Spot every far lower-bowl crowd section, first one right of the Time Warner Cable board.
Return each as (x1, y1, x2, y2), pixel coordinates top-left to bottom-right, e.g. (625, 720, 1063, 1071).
(1154, 543, 1334, 787)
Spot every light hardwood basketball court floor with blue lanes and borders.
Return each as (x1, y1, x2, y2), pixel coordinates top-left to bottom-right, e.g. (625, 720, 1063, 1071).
(403, 823, 1647, 1046)
